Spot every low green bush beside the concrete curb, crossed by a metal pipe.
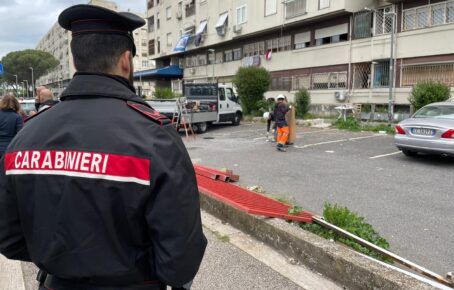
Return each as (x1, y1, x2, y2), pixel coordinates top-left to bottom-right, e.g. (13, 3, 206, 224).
(300, 203, 392, 263)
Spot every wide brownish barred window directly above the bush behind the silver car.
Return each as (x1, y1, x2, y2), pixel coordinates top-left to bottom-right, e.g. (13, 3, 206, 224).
(402, 63, 454, 87)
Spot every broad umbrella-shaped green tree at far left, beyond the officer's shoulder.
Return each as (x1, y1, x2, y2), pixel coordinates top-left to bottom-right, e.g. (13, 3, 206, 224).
(1, 49, 59, 89)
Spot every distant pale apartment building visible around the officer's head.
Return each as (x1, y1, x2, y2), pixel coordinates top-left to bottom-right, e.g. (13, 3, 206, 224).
(36, 0, 154, 96)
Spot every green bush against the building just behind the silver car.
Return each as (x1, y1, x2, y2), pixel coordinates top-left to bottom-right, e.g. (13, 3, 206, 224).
(408, 81, 451, 110)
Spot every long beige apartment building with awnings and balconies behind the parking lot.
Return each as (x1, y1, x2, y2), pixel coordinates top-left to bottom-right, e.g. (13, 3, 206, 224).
(148, 0, 454, 115)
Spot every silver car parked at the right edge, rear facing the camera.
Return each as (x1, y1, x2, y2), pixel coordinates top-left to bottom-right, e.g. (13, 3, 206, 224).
(394, 102, 454, 156)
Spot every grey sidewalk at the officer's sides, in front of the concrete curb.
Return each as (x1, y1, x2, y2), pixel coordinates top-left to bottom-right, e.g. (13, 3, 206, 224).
(0, 212, 342, 290)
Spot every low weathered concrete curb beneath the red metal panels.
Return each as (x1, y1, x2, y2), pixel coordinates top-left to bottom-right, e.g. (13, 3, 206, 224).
(200, 194, 437, 290)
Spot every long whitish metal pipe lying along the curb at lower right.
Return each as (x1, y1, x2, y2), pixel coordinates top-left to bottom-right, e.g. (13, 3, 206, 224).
(312, 215, 454, 287)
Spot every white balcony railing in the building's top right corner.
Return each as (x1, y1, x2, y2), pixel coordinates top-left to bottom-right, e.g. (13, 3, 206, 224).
(402, 1, 454, 31)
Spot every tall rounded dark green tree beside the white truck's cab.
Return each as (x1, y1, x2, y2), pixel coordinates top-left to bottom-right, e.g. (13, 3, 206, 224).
(233, 67, 271, 114)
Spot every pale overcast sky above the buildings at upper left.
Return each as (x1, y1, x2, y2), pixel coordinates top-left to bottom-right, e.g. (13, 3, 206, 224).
(0, 0, 146, 59)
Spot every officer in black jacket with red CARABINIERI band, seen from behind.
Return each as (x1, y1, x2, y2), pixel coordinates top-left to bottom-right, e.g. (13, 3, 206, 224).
(0, 5, 207, 290)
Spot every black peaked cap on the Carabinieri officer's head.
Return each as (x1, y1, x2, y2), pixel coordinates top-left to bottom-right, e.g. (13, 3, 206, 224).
(58, 4, 145, 36)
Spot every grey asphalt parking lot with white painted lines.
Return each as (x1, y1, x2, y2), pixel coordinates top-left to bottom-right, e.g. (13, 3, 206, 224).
(185, 124, 454, 275)
